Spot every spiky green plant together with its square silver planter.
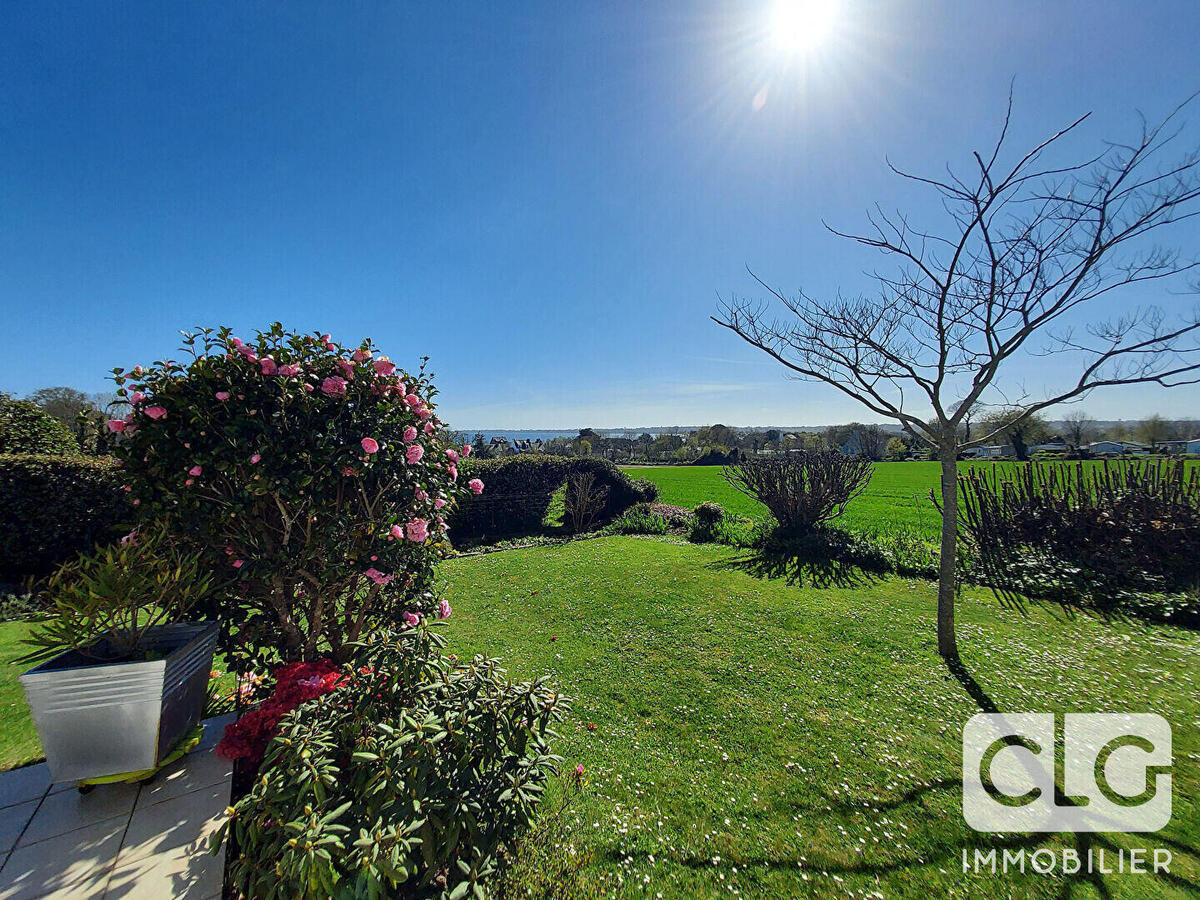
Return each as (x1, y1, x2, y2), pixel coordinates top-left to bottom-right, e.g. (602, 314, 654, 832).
(20, 524, 217, 781)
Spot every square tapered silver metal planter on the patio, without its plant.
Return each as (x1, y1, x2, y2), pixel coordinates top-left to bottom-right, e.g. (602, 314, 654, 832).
(20, 623, 217, 781)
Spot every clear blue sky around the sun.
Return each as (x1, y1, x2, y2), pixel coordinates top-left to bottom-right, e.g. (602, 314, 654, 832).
(0, 0, 1200, 428)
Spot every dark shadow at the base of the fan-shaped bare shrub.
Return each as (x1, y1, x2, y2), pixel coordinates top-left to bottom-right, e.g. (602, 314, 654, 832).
(709, 528, 888, 588)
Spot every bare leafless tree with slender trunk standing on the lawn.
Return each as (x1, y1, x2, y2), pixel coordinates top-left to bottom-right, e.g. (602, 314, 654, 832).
(714, 98, 1200, 658)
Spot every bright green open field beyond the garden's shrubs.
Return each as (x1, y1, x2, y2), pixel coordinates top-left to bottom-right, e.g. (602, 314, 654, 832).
(625, 462, 1200, 540)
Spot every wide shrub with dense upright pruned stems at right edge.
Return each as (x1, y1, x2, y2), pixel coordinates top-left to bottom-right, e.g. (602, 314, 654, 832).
(959, 461, 1200, 617)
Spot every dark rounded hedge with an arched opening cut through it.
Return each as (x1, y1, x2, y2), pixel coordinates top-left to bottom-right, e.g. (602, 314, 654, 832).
(450, 454, 659, 540)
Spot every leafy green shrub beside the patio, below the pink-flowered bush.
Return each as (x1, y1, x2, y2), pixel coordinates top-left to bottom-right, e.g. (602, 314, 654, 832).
(217, 626, 568, 900)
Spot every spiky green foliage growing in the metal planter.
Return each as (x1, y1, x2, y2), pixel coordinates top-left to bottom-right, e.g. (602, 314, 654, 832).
(26, 522, 211, 660)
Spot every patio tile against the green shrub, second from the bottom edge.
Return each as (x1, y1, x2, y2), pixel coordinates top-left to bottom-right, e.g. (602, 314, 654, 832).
(116, 782, 229, 868)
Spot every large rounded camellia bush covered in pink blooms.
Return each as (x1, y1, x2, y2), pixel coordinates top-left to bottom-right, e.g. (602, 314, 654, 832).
(108, 323, 484, 664)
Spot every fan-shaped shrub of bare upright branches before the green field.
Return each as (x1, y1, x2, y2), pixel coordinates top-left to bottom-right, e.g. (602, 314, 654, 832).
(722, 450, 874, 534)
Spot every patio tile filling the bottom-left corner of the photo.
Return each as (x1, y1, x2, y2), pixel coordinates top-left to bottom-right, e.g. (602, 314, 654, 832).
(0, 816, 125, 900)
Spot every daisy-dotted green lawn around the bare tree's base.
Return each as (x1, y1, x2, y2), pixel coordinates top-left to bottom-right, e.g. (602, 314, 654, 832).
(444, 538, 1200, 899)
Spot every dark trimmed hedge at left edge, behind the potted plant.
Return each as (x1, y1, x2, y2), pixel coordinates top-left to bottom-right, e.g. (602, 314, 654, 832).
(0, 454, 132, 583)
